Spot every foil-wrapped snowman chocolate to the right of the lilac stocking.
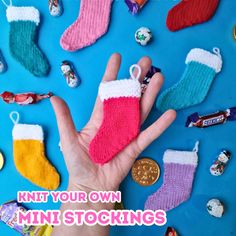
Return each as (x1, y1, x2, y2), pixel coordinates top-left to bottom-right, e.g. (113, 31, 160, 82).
(210, 150, 231, 176)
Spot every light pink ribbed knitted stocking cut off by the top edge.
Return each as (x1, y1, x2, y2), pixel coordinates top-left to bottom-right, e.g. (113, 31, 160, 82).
(60, 0, 112, 51)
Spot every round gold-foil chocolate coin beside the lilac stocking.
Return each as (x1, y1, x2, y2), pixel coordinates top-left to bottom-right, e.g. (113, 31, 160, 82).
(131, 158, 160, 186)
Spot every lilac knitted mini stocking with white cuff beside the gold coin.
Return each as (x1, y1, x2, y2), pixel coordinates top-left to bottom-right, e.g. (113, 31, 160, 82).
(145, 142, 198, 211)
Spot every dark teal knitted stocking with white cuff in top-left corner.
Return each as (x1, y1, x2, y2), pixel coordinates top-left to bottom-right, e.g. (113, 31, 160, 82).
(7, 6, 49, 76)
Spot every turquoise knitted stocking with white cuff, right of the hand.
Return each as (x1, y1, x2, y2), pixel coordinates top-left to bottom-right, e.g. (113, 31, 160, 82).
(156, 48, 222, 112)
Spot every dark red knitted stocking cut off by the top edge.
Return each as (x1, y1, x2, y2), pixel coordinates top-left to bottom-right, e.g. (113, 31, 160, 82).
(166, 0, 219, 31)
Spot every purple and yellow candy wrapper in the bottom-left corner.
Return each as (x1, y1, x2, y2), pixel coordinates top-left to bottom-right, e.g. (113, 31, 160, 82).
(0, 201, 52, 236)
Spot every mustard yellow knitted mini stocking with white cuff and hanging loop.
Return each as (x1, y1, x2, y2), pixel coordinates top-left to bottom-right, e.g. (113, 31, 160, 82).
(10, 112, 60, 190)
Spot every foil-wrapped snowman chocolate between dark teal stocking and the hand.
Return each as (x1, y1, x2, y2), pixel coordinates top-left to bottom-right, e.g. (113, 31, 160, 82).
(61, 61, 81, 88)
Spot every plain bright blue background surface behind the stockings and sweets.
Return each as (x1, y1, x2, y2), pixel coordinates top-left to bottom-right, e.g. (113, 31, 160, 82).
(0, 0, 236, 236)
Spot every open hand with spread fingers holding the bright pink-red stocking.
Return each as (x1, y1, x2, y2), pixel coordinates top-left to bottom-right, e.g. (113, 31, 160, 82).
(51, 54, 176, 196)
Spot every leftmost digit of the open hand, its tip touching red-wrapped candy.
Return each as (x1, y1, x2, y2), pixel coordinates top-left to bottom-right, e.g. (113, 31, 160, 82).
(50, 96, 77, 146)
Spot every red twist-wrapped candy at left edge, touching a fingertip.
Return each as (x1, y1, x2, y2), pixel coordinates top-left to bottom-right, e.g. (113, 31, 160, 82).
(0, 91, 52, 105)
